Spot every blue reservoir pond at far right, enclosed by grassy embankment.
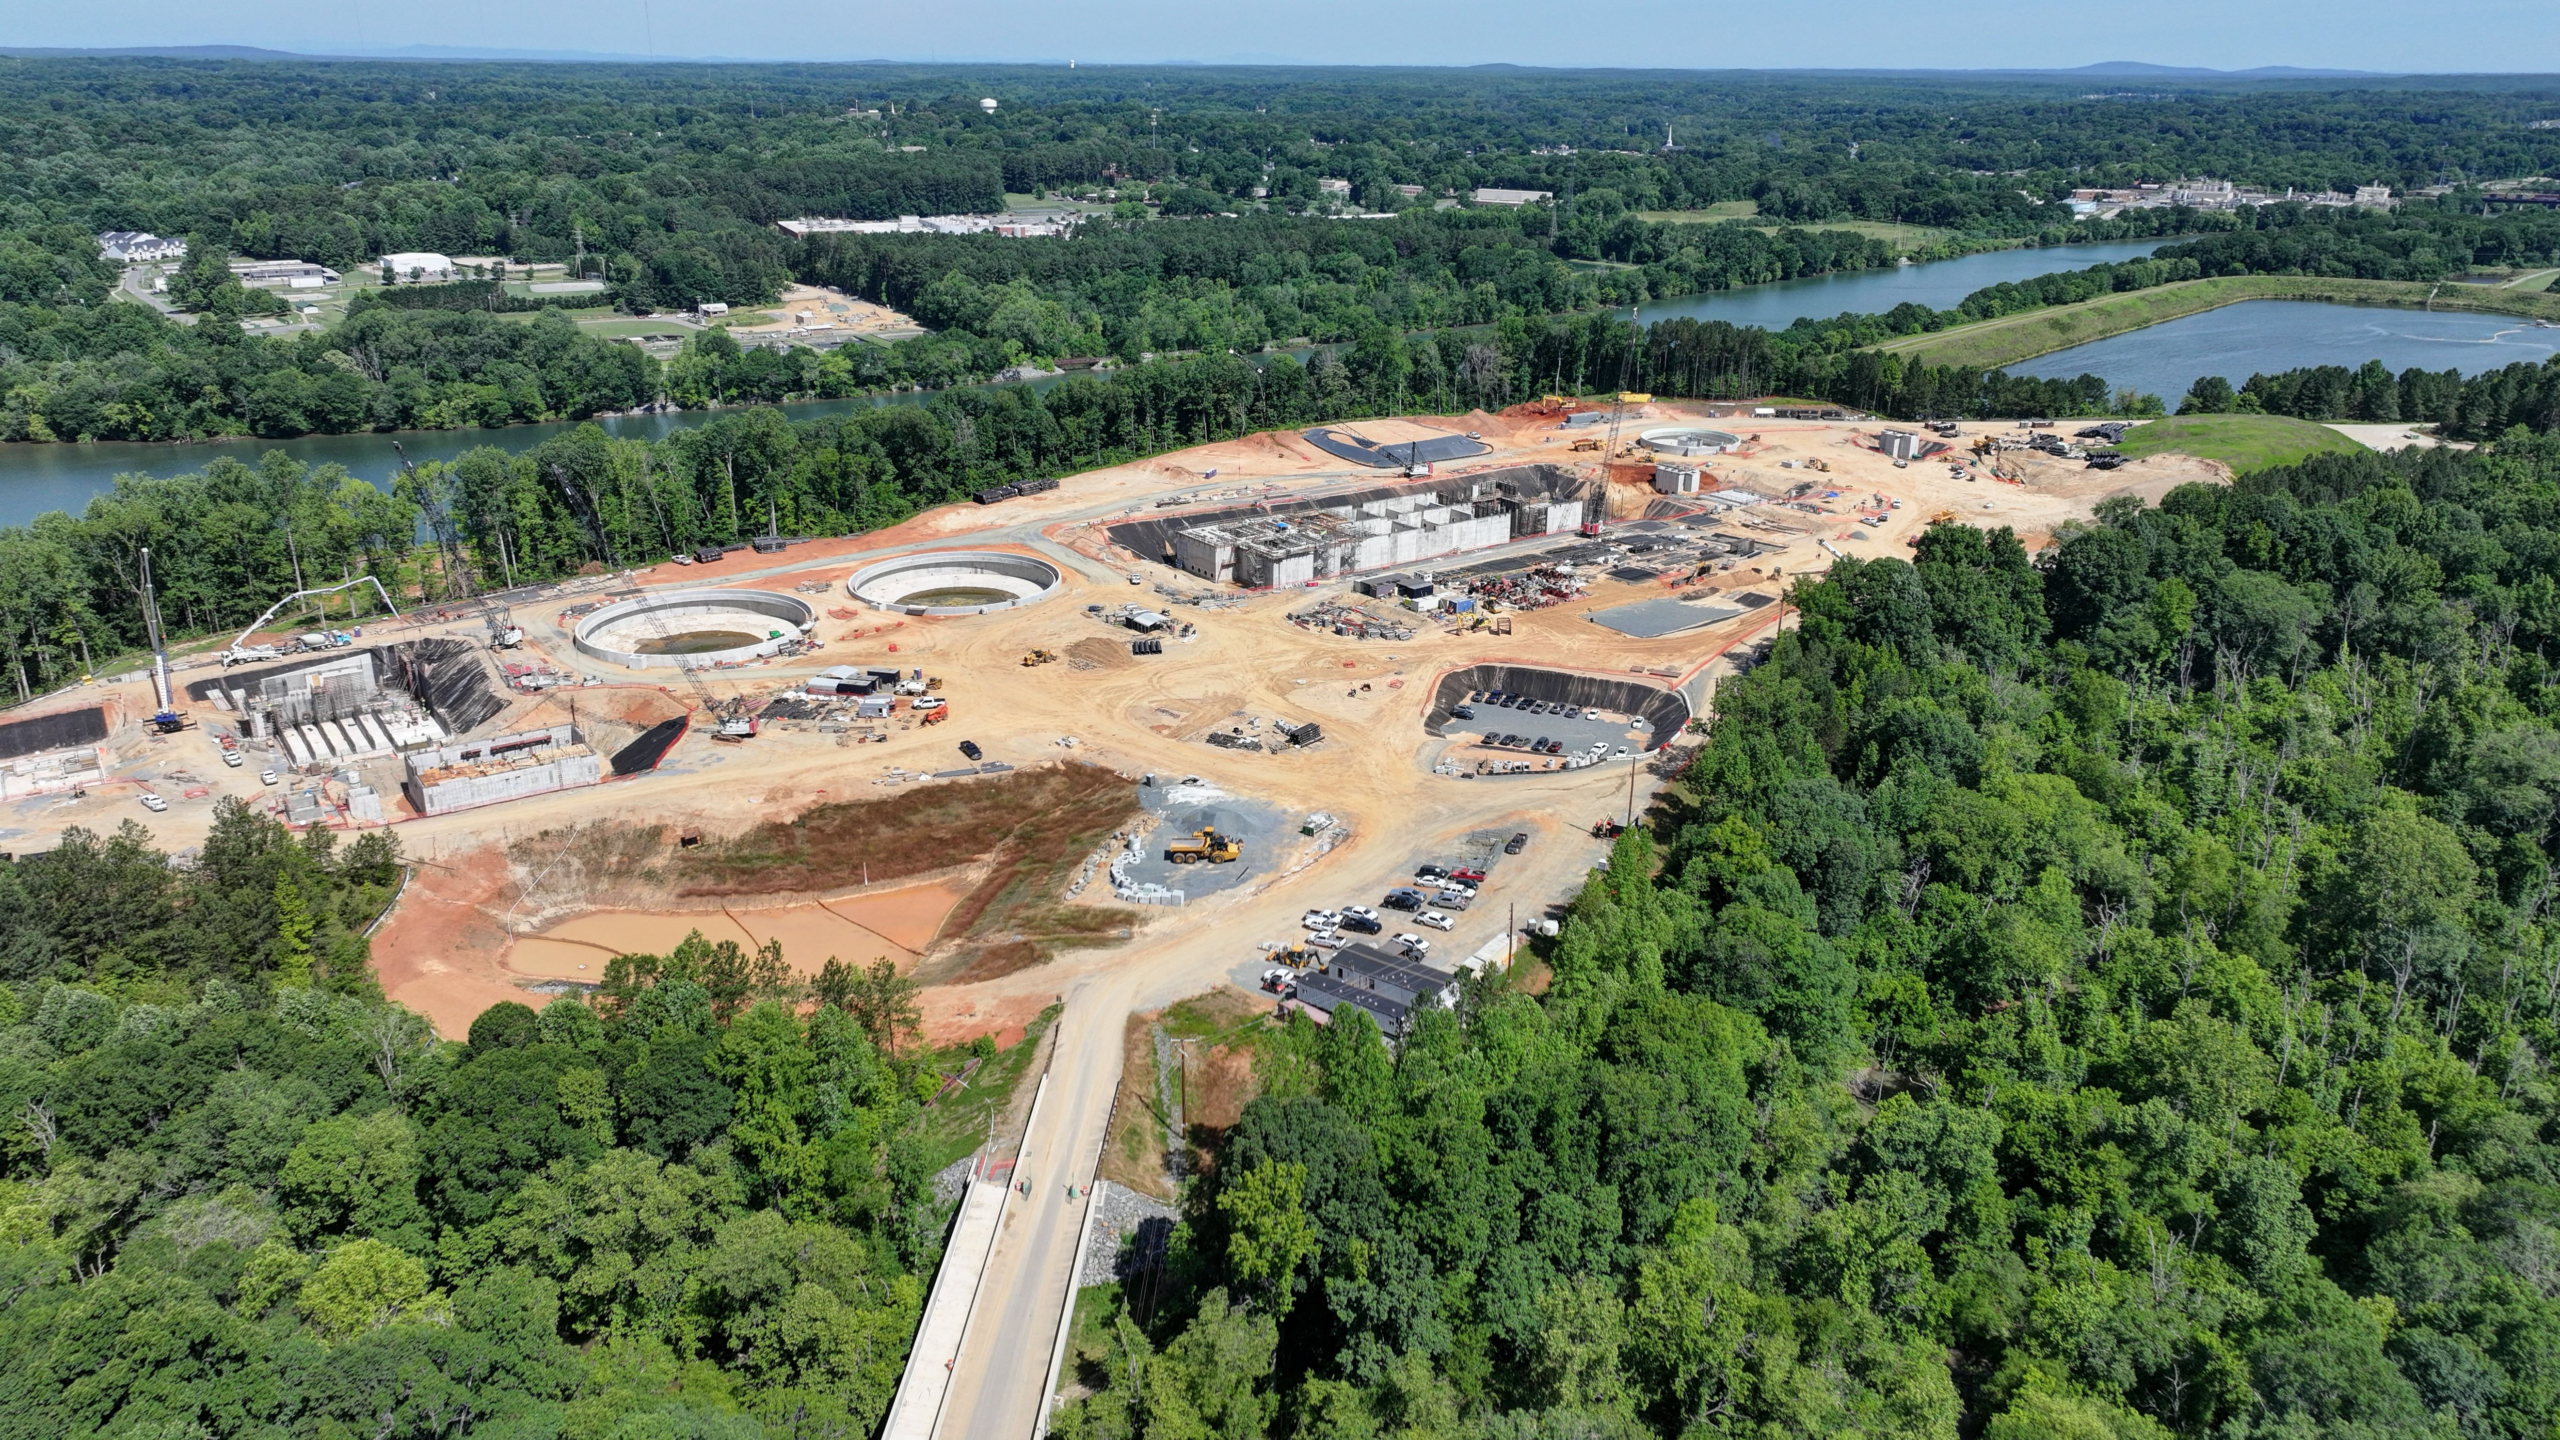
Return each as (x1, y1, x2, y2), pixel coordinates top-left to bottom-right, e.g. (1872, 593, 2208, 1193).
(2007, 300, 2560, 397)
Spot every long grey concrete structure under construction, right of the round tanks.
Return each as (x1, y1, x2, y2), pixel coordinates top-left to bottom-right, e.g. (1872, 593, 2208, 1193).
(1172, 477, 1582, 589)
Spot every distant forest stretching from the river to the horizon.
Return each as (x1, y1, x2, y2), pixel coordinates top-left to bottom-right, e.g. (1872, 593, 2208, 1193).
(0, 59, 2560, 441)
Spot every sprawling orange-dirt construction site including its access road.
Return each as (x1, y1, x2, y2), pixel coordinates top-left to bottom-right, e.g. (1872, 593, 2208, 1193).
(0, 402, 2222, 1432)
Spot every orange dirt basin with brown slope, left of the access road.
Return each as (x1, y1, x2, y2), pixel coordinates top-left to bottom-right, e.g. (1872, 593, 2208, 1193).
(374, 764, 1137, 1038)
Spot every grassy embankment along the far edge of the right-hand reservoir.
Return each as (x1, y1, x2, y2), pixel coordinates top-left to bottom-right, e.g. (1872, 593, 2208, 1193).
(1876, 274, 2560, 369)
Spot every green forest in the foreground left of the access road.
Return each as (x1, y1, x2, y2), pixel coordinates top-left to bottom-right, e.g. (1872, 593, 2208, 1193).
(0, 802, 967, 1440)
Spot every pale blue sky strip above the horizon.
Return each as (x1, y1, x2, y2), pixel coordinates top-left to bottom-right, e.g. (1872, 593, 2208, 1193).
(15, 0, 2560, 72)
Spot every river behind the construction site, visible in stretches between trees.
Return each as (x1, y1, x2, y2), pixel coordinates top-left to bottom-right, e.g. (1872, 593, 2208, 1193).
(0, 241, 2166, 525)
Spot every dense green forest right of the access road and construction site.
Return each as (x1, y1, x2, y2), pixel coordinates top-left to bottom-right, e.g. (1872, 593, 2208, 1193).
(1062, 436, 2560, 1440)
